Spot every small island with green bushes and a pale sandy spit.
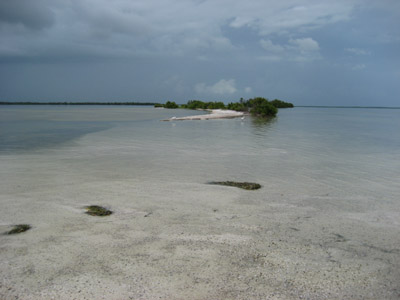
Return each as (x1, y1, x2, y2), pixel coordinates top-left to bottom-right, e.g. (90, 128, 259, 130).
(154, 97, 294, 121)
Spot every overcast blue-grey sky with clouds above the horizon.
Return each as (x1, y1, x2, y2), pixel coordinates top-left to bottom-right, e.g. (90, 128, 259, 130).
(0, 0, 400, 107)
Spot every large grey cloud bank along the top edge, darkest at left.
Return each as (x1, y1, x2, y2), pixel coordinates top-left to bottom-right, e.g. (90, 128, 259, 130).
(0, 0, 355, 56)
